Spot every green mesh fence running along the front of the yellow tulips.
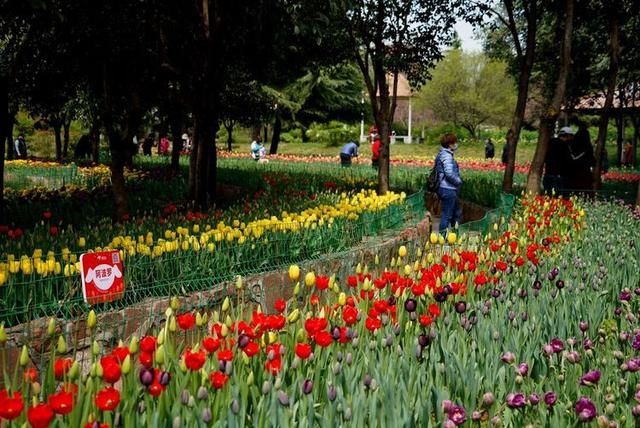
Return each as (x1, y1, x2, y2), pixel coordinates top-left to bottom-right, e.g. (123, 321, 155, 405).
(0, 192, 424, 326)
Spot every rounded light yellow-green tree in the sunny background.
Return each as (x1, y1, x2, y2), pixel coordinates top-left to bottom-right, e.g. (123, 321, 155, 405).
(417, 49, 516, 137)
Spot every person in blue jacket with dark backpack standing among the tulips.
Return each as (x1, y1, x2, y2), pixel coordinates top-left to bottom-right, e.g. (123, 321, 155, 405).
(435, 134, 463, 232)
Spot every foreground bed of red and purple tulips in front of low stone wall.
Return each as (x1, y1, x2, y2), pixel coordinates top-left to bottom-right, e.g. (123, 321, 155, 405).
(0, 197, 640, 427)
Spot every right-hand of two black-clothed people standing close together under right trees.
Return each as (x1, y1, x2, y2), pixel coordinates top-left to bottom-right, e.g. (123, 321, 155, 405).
(562, 123, 596, 193)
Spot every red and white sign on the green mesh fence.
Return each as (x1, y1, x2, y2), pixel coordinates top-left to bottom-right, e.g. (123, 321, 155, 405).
(80, 250, 124, 305)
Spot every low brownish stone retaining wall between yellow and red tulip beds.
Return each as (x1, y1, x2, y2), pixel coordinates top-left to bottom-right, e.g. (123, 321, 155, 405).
(0, 214, 431, 380)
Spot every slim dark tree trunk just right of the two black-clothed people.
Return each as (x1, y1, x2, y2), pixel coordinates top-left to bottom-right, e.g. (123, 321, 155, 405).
(593, 11, 622, 190)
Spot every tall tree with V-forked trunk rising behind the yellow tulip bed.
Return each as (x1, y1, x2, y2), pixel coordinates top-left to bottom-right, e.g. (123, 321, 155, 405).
(338, 0, 461, 193)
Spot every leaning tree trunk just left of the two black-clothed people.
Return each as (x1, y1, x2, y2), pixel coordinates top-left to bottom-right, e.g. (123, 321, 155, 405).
(527, 0, 575, 194)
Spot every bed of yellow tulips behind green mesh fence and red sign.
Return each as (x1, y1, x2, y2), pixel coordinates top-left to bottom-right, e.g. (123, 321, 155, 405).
(0, 191, 423, 324)
